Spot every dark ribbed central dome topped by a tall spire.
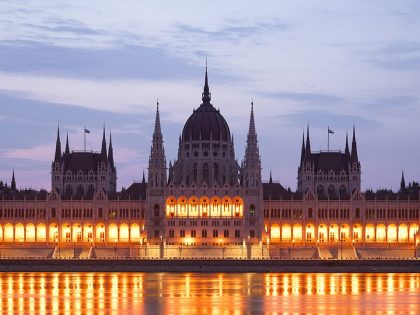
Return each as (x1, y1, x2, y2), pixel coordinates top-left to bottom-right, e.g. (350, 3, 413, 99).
(182, 68, 230, 141)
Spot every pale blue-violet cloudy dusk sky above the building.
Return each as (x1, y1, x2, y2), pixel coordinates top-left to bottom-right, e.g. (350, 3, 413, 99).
(0, 0, 420, 190)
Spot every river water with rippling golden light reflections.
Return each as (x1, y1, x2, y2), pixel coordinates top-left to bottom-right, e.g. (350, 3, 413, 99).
(0, 272, 420, 315)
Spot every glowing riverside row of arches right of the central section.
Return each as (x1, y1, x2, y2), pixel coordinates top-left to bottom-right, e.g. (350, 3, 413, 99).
(265, 223, 419, 243)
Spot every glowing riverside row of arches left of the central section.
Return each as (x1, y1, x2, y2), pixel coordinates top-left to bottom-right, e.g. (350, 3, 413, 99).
(0, 223, 143, 243)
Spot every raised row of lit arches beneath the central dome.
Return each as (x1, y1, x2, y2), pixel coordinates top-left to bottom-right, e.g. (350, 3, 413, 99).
(166, 197, 244, 217)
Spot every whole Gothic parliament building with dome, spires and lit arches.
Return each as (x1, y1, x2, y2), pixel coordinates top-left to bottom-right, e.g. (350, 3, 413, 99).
(0, 69, 420, 259)
